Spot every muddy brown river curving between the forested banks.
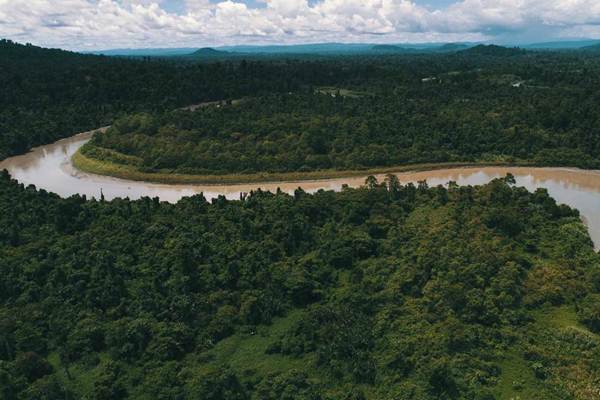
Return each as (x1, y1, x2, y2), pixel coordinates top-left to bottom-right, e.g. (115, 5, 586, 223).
(0, 132, 600, 247)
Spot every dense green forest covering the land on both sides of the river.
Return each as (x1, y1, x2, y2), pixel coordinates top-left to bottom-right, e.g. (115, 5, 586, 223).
(0, 41, 600, 400)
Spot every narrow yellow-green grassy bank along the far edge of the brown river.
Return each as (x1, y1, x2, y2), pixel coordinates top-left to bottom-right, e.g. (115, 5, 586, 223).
(71, 150, 536, 185)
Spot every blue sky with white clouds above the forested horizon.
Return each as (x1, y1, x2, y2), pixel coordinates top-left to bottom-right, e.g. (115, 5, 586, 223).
(0, 0, 600, 50)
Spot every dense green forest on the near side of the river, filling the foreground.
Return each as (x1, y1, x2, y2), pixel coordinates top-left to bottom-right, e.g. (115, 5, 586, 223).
(0, 170, 600, 400)
